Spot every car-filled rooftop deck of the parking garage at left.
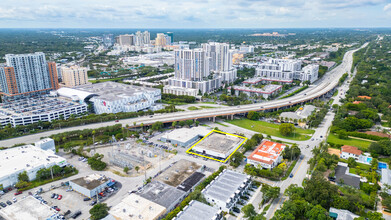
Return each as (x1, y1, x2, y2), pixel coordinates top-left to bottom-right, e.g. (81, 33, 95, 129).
(0, 95, 84, 117)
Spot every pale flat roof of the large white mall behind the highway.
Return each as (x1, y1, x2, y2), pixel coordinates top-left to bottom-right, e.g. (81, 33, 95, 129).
(73, 82, 160, 101)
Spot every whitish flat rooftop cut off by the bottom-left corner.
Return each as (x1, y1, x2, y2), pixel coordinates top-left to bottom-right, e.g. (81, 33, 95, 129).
(0, 196, 56, 220)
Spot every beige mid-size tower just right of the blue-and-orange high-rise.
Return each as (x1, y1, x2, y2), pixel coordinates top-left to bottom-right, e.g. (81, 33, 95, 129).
(61, 66, 88, 87)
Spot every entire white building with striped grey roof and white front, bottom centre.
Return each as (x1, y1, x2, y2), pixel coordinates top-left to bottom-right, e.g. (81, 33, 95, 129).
(202, 169, 251, 212)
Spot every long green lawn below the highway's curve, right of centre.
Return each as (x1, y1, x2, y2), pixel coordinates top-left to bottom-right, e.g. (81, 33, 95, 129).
(226, 119, 315, 141)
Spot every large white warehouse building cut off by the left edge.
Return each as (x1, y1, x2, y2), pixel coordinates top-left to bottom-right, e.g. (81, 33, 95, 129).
(0, 145, 68, 188)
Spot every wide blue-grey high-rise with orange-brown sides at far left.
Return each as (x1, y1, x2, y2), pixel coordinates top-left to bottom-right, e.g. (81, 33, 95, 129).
(0, 52, 58, 97)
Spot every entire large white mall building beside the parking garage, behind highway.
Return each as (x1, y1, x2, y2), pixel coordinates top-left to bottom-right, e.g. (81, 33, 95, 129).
(57, 82, 162, 114)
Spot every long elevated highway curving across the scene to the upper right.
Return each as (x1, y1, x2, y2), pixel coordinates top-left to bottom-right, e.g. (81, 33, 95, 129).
(0, 43, 368, 147)
